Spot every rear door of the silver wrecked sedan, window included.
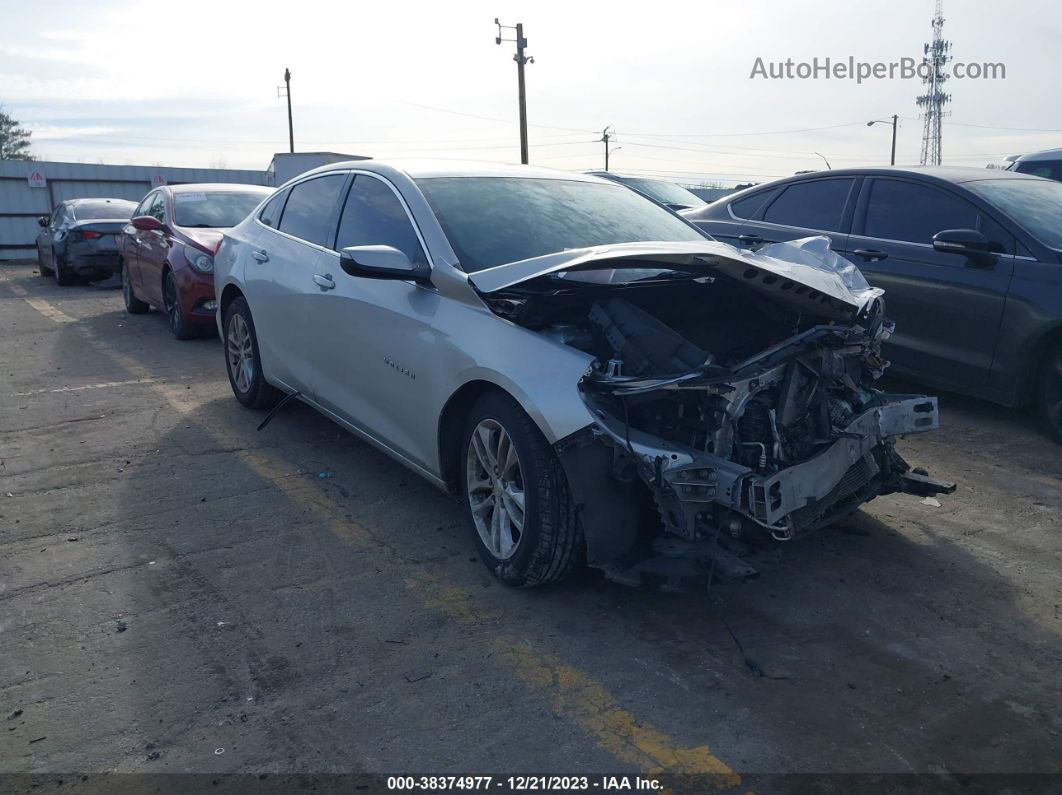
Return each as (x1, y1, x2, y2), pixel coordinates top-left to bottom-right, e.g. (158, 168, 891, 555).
(244, 172, 349, 398)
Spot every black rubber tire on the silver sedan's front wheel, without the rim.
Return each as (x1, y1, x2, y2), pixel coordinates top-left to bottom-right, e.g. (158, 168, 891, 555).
(459, 392, 586, 588)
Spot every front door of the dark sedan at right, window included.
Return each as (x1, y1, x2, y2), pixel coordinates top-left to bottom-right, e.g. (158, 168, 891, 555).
(845, 177, 1014, 387)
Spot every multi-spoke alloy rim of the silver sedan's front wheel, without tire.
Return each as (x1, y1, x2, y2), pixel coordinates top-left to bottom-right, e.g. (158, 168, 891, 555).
(465, 418, 525, 560)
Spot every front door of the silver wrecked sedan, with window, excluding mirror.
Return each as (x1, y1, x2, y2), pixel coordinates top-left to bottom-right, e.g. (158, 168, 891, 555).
(310, 168, 439, 464)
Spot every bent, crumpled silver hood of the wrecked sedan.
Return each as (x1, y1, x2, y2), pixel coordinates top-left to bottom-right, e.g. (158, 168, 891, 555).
(468, 236, 884, 312)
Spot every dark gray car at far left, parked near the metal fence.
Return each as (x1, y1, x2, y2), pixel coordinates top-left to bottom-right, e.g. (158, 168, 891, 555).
(37, 198, 136, 286)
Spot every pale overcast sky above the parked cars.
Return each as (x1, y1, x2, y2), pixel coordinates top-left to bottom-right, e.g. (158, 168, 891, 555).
(0, 0, 1062, 184)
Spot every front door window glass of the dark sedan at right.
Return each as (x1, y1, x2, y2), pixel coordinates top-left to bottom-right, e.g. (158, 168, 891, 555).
(863, 179, 977, 245)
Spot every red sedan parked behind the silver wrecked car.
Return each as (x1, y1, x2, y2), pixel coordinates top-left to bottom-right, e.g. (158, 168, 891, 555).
(118, 184, 273, 340)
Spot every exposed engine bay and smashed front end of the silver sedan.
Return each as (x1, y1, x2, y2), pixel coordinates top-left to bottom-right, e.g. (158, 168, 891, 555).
(473, 239, 955, 581)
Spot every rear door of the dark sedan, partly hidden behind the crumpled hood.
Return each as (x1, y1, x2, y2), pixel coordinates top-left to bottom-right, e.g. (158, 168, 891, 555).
(737, 176, 858, 250)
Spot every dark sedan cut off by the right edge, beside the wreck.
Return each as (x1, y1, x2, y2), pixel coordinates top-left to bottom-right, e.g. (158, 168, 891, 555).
(682, 168, 1062, 443)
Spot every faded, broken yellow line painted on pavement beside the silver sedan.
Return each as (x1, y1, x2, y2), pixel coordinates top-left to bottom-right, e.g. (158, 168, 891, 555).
(76, 314, 741, 788)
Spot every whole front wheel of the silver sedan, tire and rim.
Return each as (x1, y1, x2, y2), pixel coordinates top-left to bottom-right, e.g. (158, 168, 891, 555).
(461, 392, 585, 587)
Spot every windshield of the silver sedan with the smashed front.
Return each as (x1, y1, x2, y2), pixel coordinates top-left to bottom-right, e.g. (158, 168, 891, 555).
(416, 177, 705, 273)
